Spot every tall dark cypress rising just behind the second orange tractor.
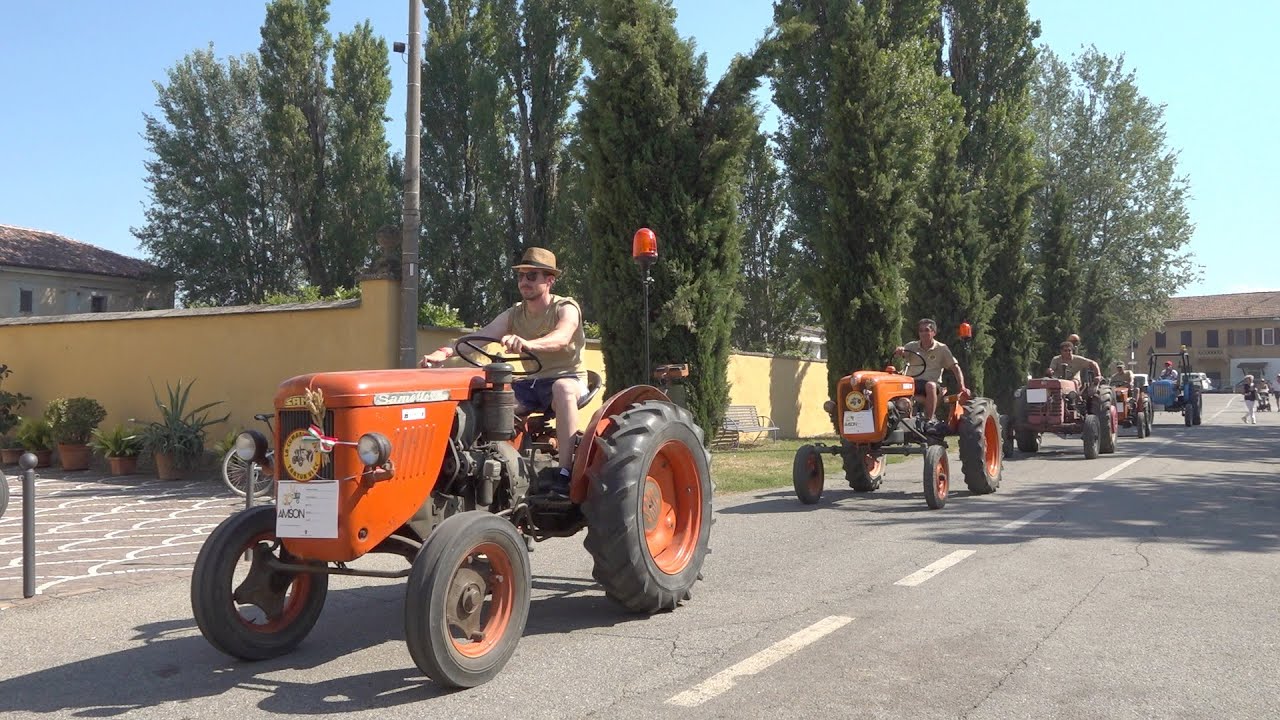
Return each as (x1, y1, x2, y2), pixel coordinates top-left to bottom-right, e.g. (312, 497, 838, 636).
(773, 0, 937, 388)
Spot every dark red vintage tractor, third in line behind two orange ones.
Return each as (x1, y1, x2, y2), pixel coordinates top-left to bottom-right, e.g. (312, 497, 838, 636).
(1005, 361, 1119, 460)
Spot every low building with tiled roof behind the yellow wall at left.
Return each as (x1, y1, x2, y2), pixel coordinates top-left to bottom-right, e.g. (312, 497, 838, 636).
(0, 224, 174, 318)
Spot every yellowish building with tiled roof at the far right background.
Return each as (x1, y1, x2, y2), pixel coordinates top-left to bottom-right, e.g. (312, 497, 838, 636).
(1134, 292, 1280, 392)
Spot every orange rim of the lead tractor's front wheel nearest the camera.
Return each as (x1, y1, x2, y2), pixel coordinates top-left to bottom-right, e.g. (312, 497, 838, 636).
(444, 542, 516, 657)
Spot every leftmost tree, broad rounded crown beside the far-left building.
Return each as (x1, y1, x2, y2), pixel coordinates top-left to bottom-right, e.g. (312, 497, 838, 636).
(133, 47, 298, 306)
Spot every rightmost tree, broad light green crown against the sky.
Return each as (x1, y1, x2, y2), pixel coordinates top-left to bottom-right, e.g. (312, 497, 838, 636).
(1034, 47, 1198, 363)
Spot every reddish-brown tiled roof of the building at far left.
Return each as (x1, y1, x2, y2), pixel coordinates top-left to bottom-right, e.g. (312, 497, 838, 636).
(0, 224, 156, 278)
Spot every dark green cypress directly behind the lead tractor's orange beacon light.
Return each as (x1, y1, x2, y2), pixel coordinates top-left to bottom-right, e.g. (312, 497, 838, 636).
(579, 0, 760, 428)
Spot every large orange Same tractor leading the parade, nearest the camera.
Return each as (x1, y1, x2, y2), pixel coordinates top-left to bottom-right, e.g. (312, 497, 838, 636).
(191, 337, 712, 687)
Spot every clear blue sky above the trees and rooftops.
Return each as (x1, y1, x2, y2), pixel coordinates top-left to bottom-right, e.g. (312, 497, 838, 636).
(0, 0, 1280, 295)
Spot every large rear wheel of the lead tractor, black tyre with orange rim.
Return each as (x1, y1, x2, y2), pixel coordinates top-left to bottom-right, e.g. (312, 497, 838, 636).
(582, 401, 712, 612)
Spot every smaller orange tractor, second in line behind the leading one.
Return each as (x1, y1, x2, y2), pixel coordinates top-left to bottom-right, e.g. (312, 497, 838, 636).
(791, 350, 1004, 510)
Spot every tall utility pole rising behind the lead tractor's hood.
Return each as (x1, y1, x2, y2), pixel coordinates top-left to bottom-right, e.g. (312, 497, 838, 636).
(399, 0, 422, 368)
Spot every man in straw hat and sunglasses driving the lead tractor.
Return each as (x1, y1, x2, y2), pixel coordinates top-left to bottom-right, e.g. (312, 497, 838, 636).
(419, 247, 588, 497)
